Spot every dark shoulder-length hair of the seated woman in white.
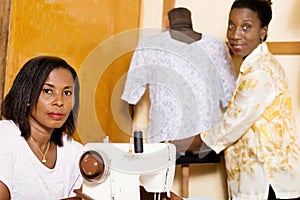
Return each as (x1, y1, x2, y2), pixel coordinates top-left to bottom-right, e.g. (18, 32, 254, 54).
(1, 56, 79, 146)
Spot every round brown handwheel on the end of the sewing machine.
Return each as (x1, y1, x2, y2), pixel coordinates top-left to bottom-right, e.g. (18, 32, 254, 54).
(79, 151, 108, 182)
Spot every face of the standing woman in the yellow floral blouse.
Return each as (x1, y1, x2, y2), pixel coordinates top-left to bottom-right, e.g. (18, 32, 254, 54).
(227, 8, 268, 57)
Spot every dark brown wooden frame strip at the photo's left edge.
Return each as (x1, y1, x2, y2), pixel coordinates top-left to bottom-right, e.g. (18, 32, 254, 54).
(0, 0, 12, 119)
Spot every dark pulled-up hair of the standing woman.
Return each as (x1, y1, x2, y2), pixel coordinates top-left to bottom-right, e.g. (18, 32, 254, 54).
(230, 0, 272, 41)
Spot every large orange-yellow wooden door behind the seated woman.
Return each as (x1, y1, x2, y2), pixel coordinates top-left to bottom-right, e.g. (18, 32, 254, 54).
(0, 0, 140, 143)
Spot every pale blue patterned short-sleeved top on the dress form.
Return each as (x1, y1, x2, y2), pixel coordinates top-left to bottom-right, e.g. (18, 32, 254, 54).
(122, 31, 236, 142)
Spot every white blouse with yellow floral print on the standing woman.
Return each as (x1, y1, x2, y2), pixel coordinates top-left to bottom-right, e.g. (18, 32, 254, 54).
(201, 43, 300, 200)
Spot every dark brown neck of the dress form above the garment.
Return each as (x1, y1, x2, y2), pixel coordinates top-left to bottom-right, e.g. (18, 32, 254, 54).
(168, 8, 202, 44)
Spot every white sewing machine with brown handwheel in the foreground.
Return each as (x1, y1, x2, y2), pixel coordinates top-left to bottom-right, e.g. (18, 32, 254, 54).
(80, 143, 176, 200)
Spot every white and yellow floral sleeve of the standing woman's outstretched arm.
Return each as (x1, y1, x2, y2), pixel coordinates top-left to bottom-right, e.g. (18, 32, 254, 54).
(201, 71, 276, 153)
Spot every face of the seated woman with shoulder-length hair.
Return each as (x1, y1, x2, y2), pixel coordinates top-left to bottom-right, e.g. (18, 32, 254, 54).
(29, 68, 75, 132)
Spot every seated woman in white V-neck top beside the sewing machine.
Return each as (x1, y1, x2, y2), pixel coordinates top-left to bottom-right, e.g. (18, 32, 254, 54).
(0, 56, 83, 199)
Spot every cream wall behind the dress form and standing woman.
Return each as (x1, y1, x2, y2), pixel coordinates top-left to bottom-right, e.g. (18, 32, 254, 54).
(141, 0, 300, 200)
